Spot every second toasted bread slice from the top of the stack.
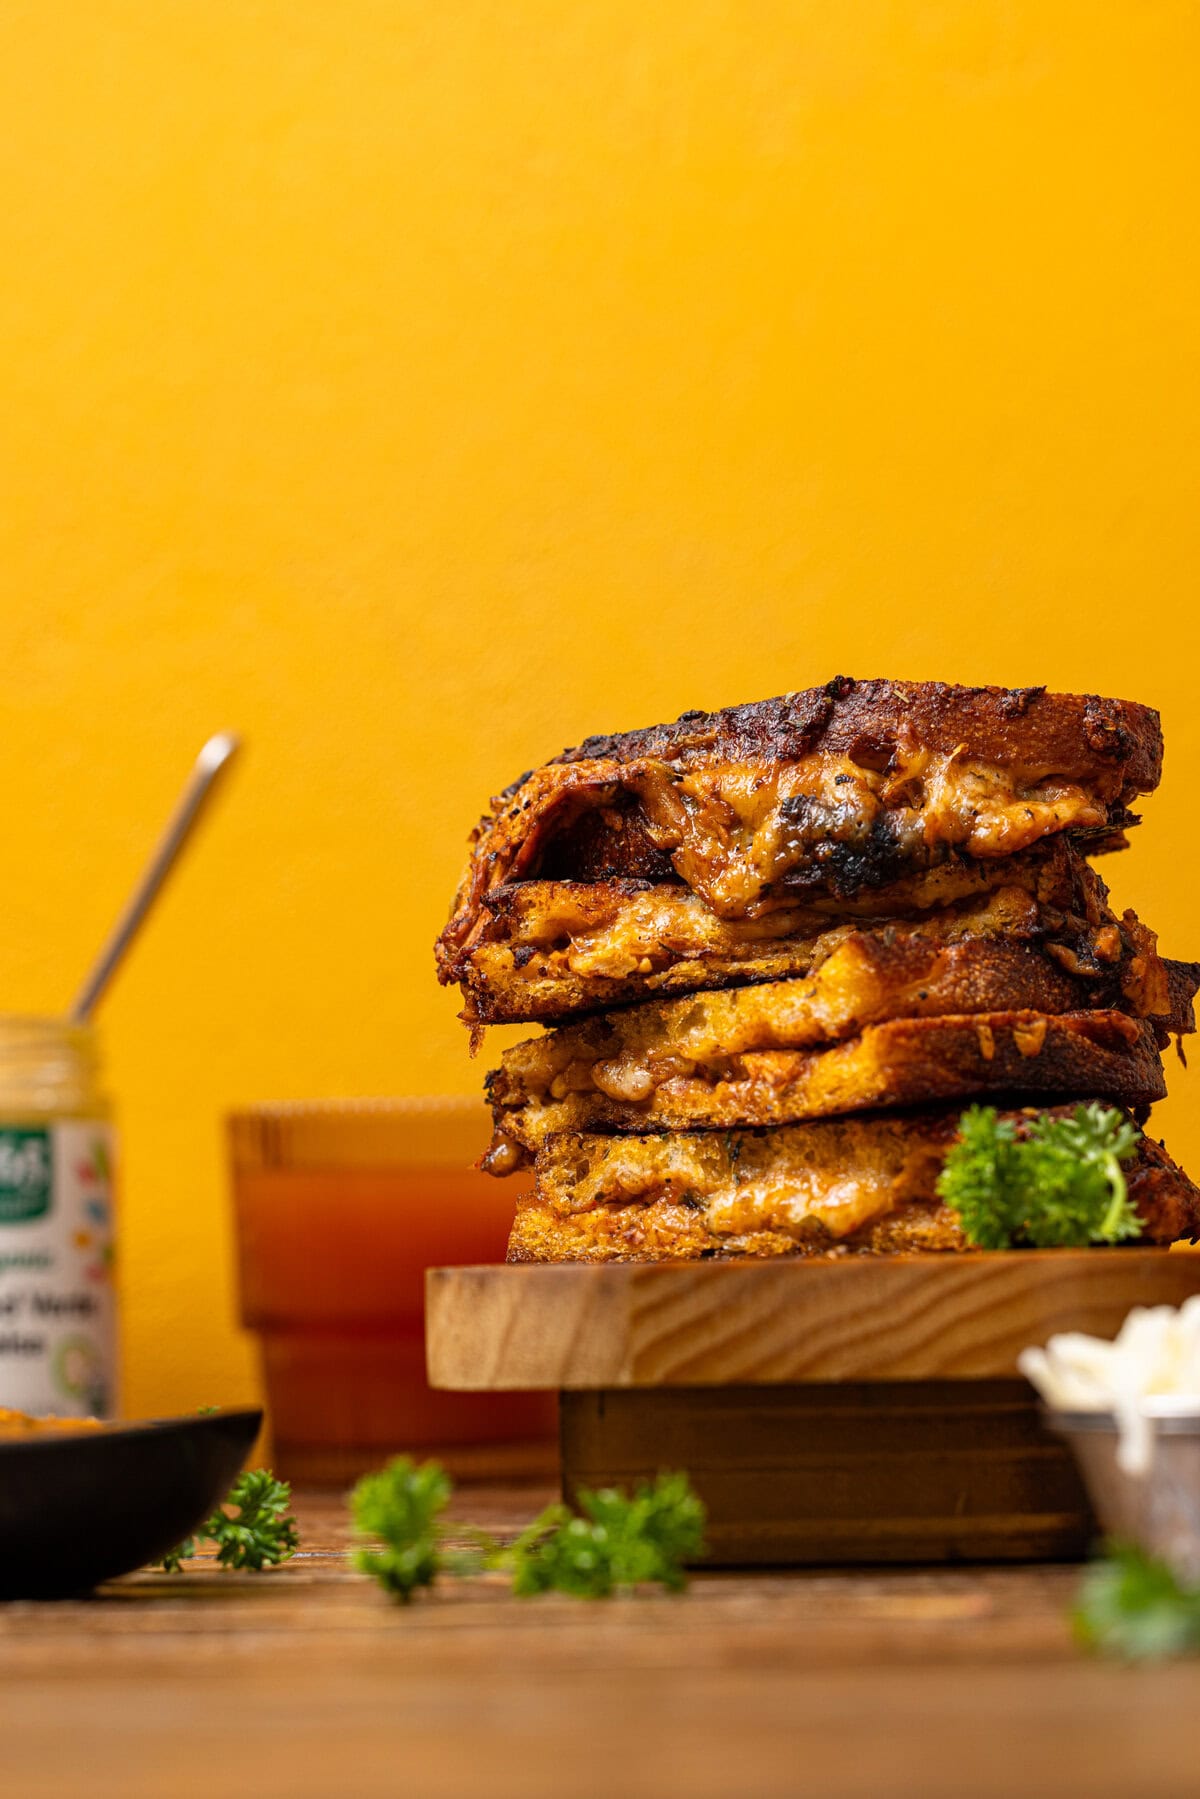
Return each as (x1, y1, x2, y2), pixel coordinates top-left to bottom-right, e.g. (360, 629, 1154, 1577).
(440, 840, 1168, 1024)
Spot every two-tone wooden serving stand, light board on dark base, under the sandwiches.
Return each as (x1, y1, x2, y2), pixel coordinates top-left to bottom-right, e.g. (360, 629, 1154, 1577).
(426, 1249, 1200, 1565)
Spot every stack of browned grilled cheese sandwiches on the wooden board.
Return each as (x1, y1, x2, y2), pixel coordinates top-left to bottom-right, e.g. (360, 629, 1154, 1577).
(437, 678, 1200, 1261)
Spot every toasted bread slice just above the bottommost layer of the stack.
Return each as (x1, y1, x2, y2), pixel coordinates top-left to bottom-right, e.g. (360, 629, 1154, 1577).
(484, 988, 1166, 1173)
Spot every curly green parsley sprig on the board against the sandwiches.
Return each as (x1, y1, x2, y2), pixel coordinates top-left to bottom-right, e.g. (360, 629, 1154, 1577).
(937, 1103, 1142, 1249)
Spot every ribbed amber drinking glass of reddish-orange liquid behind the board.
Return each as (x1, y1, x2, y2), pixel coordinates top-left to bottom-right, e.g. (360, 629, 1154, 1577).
(230, 1097, 558, 1486)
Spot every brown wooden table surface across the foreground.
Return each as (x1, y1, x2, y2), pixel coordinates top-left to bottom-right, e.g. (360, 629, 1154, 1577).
(0, 1486, 1200, 1799)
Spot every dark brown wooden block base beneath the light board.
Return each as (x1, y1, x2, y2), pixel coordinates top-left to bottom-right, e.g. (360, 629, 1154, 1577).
(561, 1380, 1096, 1567)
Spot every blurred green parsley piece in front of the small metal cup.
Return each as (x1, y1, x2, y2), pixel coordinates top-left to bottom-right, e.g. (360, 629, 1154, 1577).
(1072, 1544, 1200, 1660)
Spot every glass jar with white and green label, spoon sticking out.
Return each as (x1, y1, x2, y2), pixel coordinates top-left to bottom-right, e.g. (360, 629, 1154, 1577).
(0, 1016, 117, 1418)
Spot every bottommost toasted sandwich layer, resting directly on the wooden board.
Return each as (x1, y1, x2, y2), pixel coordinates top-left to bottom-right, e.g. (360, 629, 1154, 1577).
(509, 1106, 1200, 1261)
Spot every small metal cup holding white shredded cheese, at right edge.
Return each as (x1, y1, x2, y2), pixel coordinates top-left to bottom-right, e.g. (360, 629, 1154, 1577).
(1045, 1398, 1200, 1585)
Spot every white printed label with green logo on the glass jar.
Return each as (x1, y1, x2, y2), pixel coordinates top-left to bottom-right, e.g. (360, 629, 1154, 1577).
(0, 1119, 115, 1418)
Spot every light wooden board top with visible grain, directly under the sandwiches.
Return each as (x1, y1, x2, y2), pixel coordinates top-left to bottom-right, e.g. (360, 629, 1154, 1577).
(426, 1249, 1200, 1391)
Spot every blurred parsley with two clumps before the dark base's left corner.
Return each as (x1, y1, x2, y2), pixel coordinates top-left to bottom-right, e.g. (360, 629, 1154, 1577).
(351, 1455, 705, 1603)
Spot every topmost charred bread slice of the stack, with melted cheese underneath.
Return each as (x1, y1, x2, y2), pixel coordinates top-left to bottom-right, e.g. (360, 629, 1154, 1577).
(441, 678, 1162, 980)
